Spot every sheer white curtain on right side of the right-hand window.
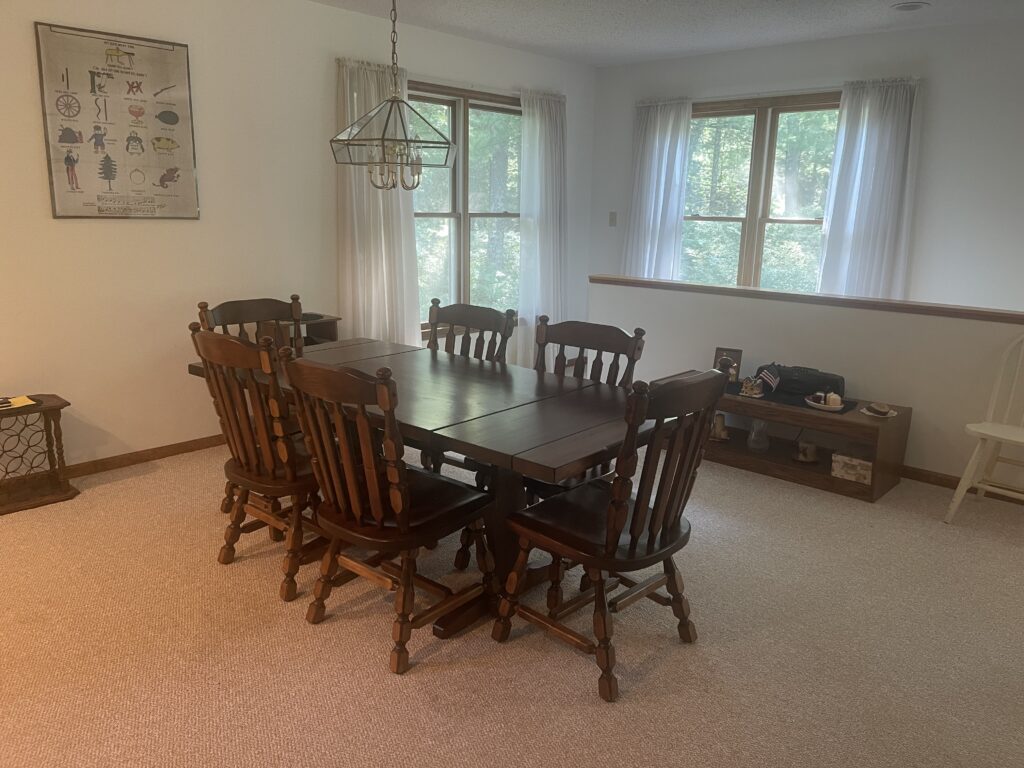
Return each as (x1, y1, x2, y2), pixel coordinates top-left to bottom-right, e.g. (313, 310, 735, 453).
(818, 79, 919, 299)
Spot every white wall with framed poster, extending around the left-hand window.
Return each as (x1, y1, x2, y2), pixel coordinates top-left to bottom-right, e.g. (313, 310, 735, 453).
(0, 0, 594, 463)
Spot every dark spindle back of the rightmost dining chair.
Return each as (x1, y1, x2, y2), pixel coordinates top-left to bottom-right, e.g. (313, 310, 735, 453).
(605, 371, 729, 555)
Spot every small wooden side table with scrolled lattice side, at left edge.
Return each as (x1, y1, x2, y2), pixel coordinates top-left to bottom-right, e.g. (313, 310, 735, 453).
(0, 394, 78, 515)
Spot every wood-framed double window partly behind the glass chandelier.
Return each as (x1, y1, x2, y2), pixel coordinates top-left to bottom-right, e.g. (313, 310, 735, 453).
(409, 83, 522, 322)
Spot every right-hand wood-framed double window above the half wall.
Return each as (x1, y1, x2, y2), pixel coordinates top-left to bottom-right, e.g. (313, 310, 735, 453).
(680, 92, 840, 293)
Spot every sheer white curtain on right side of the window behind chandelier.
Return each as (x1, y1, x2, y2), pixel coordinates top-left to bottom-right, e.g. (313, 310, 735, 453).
(508, 91, 568, 367)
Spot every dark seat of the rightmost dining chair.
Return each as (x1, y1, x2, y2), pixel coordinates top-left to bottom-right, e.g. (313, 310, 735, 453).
(508, 477, 690, 571)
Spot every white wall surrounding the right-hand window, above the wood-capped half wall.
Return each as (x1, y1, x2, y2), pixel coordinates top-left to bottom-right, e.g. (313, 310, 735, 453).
(592, 24, 1024, 309)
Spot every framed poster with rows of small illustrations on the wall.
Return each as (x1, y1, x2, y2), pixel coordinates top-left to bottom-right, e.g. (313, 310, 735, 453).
(36, 22, 199, 219)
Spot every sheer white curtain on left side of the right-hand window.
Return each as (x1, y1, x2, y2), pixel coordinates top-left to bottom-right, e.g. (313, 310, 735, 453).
(623, 99, 692, 280)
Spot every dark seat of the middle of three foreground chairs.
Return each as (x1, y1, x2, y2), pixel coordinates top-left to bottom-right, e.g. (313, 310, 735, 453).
(316, 467, 490, 551)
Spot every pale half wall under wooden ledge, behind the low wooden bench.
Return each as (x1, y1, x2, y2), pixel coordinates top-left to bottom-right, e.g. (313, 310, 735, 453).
(589, 284, 1024, 476)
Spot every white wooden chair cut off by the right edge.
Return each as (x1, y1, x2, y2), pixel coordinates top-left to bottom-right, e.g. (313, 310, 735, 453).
(945, 336, 1024, 522)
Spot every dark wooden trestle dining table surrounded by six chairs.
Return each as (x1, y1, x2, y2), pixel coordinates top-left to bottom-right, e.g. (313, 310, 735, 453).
(188, 338, 643, 637)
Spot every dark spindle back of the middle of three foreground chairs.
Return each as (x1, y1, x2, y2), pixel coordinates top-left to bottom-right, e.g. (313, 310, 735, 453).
(281, 348, 409, 531)
